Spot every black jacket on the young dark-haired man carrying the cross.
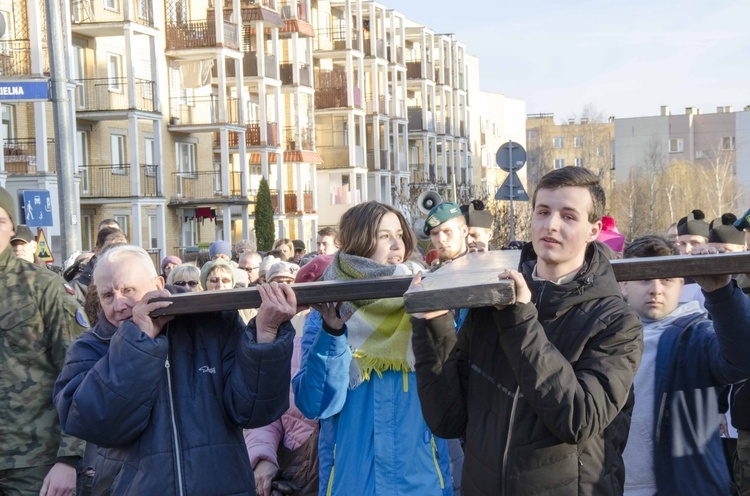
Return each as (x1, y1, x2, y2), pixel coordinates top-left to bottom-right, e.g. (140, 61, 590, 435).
(412, 244, 643, 496)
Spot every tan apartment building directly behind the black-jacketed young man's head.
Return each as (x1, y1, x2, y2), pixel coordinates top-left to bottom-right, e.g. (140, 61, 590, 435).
(526, 114, 615, 194)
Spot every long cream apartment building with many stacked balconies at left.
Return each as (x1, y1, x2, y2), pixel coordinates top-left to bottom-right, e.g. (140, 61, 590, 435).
(0, 0, 478, 263)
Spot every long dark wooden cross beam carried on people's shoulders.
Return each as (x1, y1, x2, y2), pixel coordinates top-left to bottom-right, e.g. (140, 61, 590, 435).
(154, 250, 750, 316)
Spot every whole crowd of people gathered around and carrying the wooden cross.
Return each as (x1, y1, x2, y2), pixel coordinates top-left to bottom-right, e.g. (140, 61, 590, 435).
(0, 167, 750, 496)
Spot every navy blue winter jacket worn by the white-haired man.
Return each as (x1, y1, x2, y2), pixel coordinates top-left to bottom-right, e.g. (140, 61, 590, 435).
(54, 311, 294, 496)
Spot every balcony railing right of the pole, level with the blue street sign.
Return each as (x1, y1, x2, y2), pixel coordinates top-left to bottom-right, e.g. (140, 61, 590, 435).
(75, 78, 154, 112)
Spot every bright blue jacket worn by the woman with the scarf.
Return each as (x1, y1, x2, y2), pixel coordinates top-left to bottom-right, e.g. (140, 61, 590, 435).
(292, 311, 453, 496)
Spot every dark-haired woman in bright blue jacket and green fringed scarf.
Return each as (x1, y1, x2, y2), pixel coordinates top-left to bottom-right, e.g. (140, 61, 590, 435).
(292, 202, 453, 496)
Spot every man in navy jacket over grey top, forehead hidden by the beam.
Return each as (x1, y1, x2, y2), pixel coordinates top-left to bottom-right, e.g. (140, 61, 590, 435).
(621, 234, 750, 496)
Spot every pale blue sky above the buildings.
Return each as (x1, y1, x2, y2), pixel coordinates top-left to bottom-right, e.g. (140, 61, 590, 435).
(388, 0, 750, 121)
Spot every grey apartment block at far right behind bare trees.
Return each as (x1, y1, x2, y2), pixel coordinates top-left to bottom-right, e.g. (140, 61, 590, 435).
(614, 106, 750, 190)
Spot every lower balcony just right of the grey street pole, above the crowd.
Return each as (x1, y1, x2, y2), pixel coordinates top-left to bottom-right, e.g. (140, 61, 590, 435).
(79, 164, 161, 198)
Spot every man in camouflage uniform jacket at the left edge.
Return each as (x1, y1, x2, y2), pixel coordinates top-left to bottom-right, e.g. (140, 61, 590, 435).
(0, 188, 88, 496)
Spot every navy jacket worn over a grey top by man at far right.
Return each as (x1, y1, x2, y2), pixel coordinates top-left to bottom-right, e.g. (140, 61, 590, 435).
(656, 281, 750, 495)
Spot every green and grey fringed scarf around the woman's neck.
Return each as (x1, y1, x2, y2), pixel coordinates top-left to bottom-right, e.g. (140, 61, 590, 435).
(323, 251, 421, 388)
